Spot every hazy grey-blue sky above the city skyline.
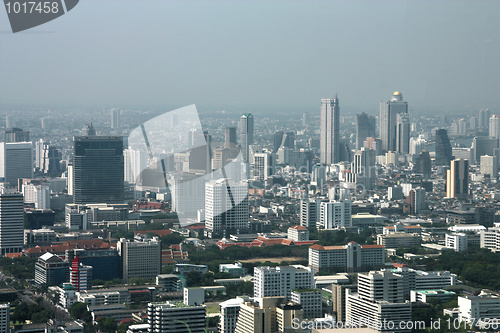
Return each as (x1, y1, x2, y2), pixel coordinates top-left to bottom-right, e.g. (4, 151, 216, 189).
(0, 0, 500, 114)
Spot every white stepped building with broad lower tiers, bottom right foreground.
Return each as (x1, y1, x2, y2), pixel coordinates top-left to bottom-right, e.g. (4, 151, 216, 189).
(346, 271, 412, 332)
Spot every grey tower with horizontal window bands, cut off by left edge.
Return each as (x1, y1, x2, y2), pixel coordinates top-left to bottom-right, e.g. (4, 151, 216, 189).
(0, 193, 24, 256)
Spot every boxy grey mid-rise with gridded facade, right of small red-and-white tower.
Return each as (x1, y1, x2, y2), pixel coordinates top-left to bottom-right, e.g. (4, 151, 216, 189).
(117, 237, 161, 282)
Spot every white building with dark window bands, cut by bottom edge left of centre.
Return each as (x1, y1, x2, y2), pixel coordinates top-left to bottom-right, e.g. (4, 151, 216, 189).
(148, 302, 206, 333)
